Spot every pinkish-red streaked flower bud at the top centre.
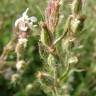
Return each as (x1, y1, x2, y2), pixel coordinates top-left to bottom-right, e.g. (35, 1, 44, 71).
(45, 0, 61, 33)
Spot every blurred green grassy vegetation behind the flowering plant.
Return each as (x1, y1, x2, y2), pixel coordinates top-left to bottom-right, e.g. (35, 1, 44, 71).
(0, 0, 96, 96)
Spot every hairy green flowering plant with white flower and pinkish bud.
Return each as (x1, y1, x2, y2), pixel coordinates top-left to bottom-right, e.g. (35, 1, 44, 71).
(0, 0, 85, 96)
